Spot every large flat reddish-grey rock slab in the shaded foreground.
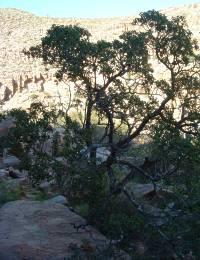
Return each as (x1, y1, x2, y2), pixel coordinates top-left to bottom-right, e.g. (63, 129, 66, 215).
(0, 200, 112, 260)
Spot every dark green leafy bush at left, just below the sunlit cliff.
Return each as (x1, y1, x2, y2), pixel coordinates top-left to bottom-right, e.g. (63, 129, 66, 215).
(0, 103, 56, 184)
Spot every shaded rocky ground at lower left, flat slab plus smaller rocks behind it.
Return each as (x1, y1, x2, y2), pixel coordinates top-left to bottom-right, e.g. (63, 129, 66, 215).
(0, 164, 131, 260)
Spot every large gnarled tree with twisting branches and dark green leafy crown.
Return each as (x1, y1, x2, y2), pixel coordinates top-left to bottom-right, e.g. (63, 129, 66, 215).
(26, 11, 200, 187)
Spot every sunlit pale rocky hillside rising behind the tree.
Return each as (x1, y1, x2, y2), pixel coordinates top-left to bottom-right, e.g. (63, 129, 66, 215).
(0, 4, 200, 109)
